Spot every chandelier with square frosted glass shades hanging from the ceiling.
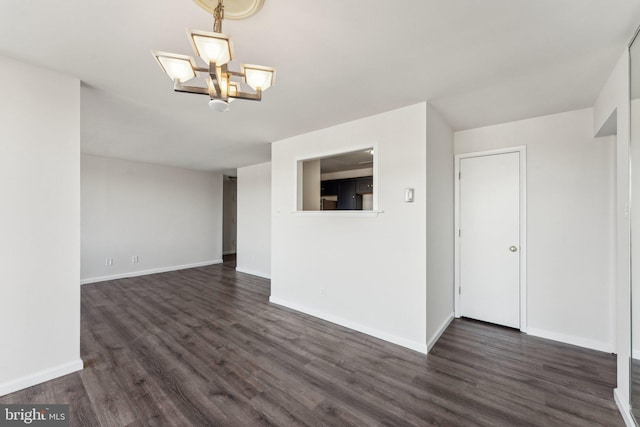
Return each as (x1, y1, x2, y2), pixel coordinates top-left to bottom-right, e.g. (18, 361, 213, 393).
(151, 0, 276, 112)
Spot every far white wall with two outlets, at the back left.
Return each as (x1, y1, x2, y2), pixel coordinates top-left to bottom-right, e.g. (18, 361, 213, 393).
(82, 155, 223, 283)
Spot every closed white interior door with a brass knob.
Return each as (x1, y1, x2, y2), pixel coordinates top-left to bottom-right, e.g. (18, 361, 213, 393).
(459, 152, 520, 328)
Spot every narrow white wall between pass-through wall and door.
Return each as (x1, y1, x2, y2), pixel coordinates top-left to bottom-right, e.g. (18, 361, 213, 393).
(427, 105, 454, 348)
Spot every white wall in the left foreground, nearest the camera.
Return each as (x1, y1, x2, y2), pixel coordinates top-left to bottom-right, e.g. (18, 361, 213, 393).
(0, 57, 82, 396)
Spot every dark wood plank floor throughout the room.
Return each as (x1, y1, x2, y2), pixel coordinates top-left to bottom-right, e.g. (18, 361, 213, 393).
(0, 260, 624, 427)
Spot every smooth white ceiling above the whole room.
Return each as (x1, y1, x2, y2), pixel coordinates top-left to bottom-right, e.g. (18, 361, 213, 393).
(0, 0, 640, 170)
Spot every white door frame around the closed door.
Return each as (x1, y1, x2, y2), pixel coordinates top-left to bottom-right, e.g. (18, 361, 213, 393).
(454, 145, 527, 332)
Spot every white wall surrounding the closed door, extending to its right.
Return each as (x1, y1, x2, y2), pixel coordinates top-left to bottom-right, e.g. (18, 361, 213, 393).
(454, 109, 615, 352)
